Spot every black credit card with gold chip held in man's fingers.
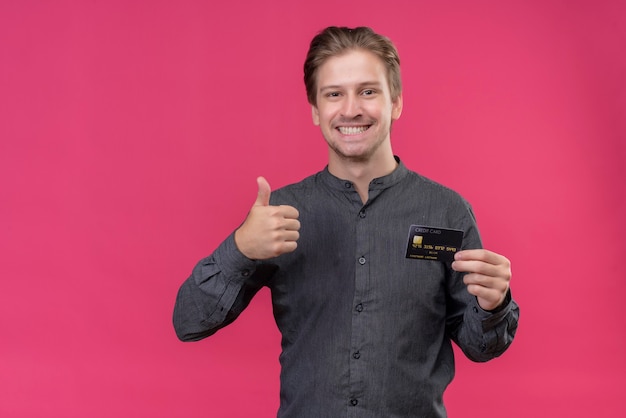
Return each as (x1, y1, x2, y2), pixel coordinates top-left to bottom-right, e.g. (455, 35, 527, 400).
(406, 225, 463, 262)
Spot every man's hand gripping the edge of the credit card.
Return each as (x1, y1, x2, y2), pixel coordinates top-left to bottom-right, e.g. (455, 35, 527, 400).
(452, 249, 511, 311)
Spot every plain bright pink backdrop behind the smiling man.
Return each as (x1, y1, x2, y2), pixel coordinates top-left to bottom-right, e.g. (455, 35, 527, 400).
(0, 0, 626, 418)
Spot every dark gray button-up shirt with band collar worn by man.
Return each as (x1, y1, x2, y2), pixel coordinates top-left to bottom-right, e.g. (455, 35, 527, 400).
(174, 158, 519, 418)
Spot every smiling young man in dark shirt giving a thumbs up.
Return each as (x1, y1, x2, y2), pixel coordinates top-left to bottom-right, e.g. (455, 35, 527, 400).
(174, 27, 519, 418)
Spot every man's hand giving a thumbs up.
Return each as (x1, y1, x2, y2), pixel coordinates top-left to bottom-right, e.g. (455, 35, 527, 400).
(235, 177, 300, 260)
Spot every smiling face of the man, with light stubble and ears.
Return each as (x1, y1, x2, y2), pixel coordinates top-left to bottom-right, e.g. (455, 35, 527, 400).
(312, 50, 402, 161)
